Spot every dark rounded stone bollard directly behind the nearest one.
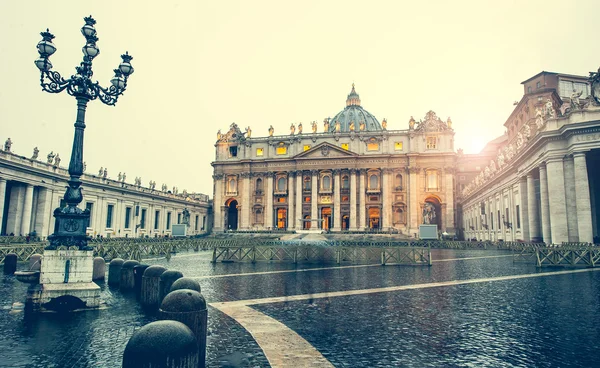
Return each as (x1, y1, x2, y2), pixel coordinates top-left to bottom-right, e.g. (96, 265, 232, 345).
(158, 289, 208, 368)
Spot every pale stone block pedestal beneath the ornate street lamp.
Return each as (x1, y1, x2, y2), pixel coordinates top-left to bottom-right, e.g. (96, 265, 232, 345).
(27, 248, 100, 310)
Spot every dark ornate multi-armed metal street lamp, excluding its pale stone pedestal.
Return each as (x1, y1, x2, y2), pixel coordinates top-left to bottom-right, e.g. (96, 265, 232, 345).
(35, 16, 133, 250)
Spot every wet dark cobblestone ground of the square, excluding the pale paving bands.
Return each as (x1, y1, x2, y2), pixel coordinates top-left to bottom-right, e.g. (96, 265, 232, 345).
(0, 250, 600, 367)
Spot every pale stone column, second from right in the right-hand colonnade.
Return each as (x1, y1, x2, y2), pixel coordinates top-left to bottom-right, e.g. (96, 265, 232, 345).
(546, 157, 569, 244)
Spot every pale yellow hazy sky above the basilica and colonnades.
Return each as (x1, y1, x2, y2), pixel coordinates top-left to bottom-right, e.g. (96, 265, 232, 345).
(0, 0, 600, 196)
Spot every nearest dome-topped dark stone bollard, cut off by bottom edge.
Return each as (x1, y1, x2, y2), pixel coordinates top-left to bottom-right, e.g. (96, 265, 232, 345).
(123, 321, 198, 368)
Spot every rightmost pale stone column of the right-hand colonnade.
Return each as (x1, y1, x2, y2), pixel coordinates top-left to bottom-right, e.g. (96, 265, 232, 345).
(573, 152, 594, 243)
